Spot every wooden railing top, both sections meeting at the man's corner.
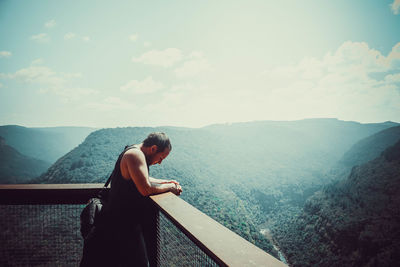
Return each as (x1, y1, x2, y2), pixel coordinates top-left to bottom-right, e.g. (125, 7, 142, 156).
(0, 184, 286, 267)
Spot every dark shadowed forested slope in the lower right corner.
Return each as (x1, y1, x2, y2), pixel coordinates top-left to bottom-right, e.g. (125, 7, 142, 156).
(274, 140, 400, 266)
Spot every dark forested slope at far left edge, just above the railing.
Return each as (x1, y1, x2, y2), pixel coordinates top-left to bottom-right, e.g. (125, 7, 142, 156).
(0, 136, 51, 184)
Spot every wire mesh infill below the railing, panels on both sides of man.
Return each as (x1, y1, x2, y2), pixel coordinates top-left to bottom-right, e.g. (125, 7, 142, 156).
(0, 205, 218, 267)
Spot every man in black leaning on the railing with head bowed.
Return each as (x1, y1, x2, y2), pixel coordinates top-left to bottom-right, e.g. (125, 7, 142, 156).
(80, 133, 182, 267)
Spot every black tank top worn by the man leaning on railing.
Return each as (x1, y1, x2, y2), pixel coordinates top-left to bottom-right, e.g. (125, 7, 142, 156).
(103, 145, 148, 230)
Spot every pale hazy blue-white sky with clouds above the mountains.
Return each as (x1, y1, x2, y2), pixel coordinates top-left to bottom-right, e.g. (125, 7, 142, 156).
(0, 0, 400, 128)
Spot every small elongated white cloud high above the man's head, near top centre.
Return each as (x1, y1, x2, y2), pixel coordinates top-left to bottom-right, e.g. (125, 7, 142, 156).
(132, 48, 183, 67)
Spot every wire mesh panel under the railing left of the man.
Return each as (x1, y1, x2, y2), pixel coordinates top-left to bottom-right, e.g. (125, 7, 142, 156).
(0, 205, 83, 266)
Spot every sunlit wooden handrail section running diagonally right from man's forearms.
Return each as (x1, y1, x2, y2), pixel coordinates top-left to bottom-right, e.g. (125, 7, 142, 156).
(150, 193, 286, 267)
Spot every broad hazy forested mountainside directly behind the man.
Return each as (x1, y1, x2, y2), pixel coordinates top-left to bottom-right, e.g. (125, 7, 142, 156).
(35, 119, 392, 258)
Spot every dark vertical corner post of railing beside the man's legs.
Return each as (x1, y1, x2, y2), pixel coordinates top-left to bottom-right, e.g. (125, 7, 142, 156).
(142, 199, 160, 267)
